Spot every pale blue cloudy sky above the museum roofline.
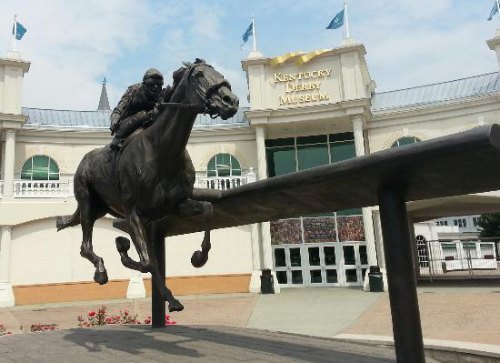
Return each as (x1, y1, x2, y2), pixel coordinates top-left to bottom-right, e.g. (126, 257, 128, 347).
(0, 0, 500, 110)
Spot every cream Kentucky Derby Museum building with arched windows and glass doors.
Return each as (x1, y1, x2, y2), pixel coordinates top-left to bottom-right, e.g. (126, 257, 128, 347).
(0, 33, 500, 306)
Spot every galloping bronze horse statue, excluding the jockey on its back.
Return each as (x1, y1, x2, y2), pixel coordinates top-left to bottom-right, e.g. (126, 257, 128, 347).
(56, 59, 239, 311)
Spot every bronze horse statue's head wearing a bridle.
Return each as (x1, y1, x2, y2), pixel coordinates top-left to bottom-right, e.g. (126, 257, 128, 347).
(174, 59, 239, 120)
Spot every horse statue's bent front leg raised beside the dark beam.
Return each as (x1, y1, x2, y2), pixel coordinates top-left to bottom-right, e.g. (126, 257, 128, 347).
(179, 199, 213, 267)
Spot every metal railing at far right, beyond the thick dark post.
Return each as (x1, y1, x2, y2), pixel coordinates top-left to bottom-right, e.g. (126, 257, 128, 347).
(417, 240, 500, 281)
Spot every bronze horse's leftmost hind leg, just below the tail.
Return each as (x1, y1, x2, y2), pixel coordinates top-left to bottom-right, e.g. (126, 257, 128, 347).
(79, 198, 108, 285)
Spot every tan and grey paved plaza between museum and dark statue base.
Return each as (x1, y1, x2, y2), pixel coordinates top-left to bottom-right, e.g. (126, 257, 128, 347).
(0, 286, 500, 357)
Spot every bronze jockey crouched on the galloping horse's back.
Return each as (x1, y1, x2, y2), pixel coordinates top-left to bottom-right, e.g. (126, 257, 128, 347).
(109, 68, 172, 150)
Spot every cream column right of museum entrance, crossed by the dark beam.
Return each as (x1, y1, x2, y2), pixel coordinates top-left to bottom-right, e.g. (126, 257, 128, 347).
(352, 116, 377, 291)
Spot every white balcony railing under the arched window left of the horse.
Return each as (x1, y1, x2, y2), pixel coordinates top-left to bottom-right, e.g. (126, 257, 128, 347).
(12, 179, 73, 198)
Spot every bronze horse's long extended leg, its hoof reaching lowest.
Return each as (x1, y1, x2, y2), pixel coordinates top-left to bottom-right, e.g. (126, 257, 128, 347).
(128, 210, 184, 311)
